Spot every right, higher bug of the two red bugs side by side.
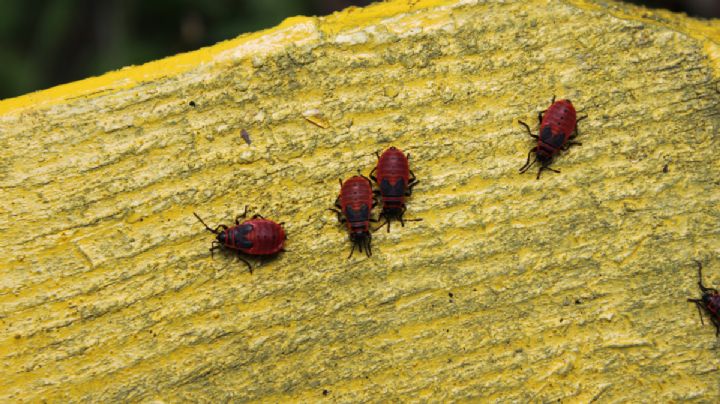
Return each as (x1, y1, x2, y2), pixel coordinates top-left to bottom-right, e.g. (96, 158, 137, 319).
(370, 146, 422, 232)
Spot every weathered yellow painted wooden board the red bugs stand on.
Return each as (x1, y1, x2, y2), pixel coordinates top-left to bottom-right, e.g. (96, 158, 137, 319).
(0, 0, 720, 402)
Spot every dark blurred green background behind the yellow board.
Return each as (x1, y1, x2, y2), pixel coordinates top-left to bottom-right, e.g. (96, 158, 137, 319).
(0, 0, 720, 99)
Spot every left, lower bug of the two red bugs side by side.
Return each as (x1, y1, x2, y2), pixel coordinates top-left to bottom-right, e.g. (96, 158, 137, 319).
(330, 175, 377, 258)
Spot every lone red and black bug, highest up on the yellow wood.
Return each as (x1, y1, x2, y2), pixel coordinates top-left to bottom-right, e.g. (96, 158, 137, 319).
(518, 97, 587, 179)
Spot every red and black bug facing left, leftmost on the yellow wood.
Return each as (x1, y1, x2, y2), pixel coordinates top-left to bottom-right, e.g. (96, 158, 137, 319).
(193, 206, 287, 273)
